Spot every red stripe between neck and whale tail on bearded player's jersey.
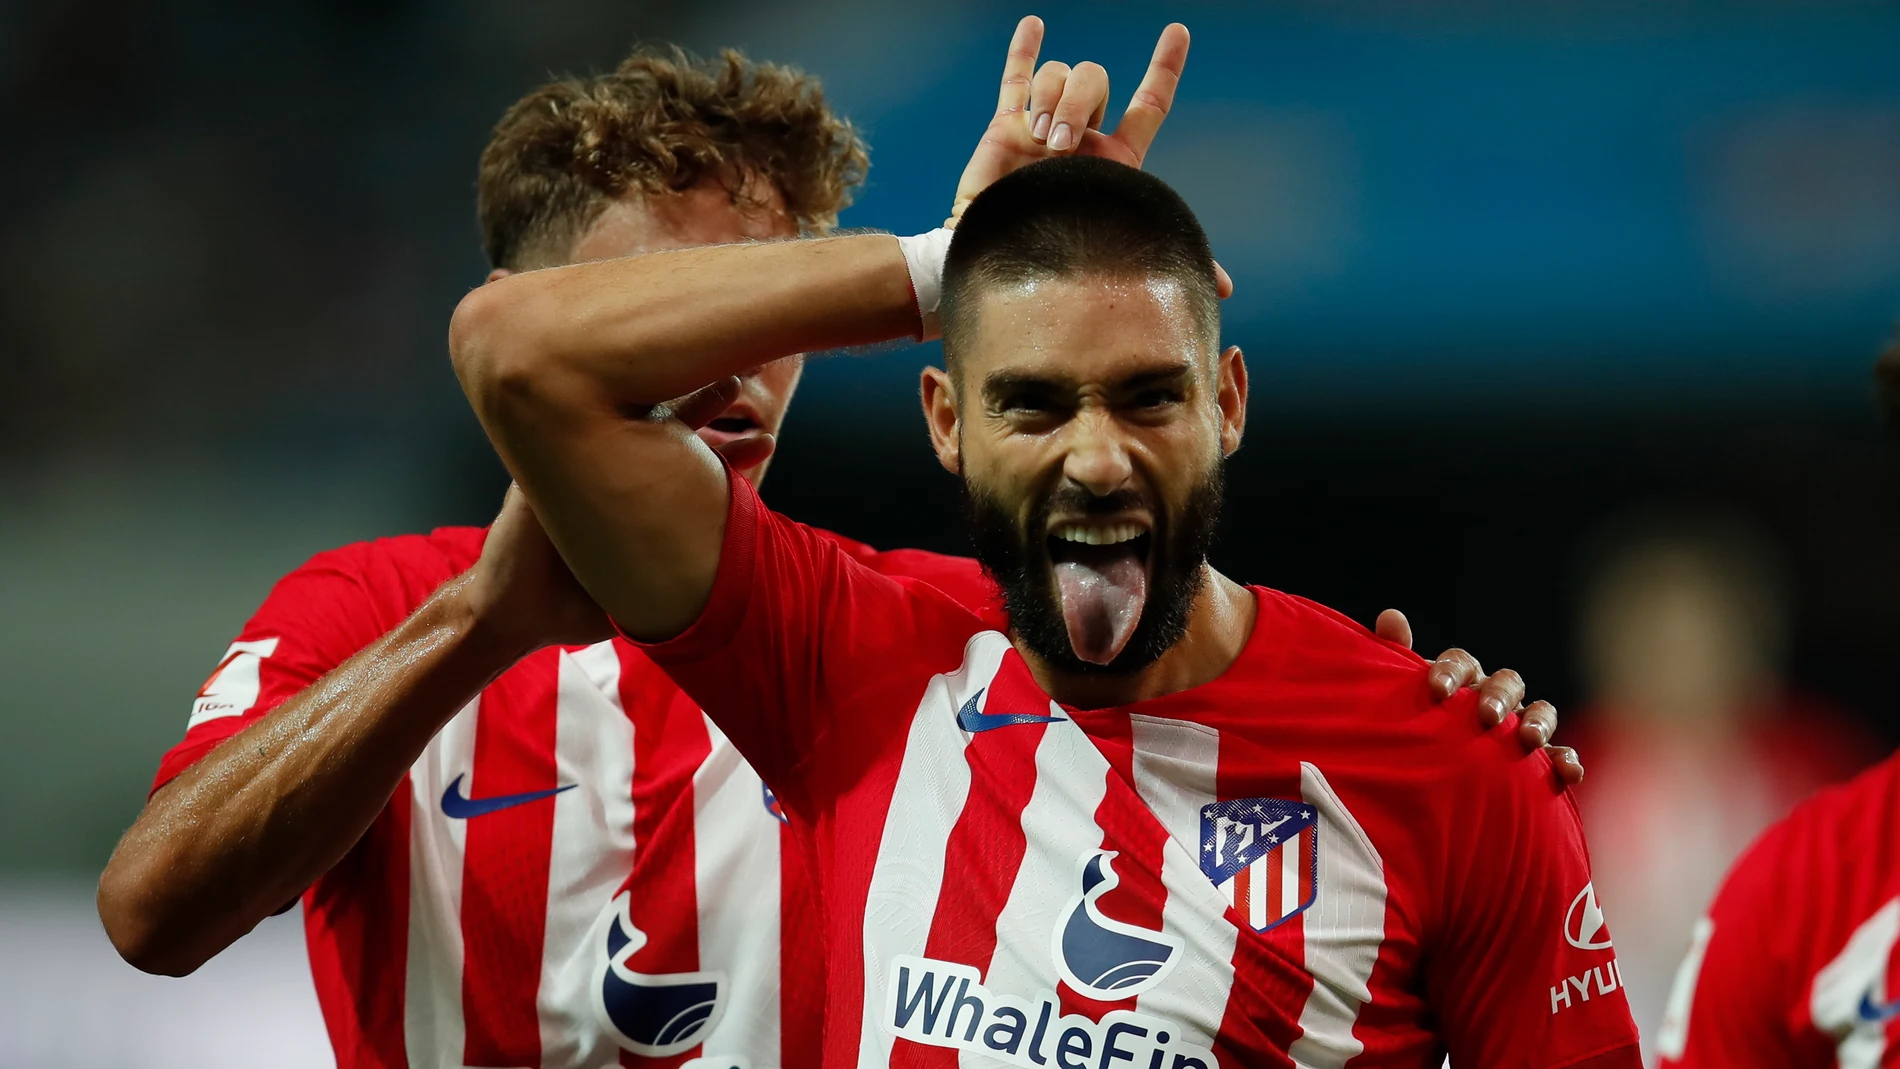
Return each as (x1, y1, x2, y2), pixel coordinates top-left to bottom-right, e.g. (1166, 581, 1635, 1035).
(1056, 714, 1169, 1022)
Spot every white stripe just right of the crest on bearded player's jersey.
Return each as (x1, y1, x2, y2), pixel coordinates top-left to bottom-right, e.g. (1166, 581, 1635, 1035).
(1286, 761, 1385, 1069)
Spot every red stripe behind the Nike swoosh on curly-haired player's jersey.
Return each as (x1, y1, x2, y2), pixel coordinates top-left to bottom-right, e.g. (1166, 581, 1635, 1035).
(462, 649, 561, 1065)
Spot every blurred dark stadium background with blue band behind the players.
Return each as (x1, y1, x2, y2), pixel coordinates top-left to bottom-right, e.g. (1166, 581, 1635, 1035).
(0, 0, 1900, 1069)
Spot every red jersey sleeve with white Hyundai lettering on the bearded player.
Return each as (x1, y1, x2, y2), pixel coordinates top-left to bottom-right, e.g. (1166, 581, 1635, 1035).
(1425, 727, 1642, 1069)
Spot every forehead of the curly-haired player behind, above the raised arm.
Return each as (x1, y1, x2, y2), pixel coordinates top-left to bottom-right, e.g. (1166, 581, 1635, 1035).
(572, 178, 798, 262)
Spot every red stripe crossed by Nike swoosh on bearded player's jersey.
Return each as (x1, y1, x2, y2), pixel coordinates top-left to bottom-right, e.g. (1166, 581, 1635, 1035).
(891, 649, 1049, 1069)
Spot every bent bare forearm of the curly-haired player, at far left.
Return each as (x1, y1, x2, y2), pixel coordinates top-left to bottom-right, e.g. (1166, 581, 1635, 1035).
(99, 579, 519, 974)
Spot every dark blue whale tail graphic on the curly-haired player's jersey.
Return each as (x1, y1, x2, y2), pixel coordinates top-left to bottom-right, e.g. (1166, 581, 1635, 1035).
(595, 891, 726, 1058)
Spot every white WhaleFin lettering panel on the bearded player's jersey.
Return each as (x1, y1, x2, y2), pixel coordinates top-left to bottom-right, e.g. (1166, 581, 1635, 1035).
(882, 955, 1220, 1069)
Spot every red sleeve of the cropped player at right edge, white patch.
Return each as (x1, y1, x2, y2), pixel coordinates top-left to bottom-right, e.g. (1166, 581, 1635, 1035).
(1657, 826, 1834, 1069)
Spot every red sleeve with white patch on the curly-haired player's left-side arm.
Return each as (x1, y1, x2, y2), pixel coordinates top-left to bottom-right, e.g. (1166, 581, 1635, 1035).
(152, 551, 388, 792)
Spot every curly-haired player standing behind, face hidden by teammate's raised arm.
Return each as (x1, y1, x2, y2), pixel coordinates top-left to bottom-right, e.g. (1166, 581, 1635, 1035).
(99, 20, 1577, 1069)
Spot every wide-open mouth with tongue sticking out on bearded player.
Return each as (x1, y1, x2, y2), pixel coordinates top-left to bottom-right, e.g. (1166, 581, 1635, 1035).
(1047, 516, 1155, 665)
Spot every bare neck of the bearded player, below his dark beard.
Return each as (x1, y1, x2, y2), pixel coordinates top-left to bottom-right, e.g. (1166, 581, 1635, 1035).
(1017, 564, 1260, 708)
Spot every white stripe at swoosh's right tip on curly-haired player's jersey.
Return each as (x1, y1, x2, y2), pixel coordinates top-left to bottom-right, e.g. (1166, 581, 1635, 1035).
(539, 642, 633, 1065)
